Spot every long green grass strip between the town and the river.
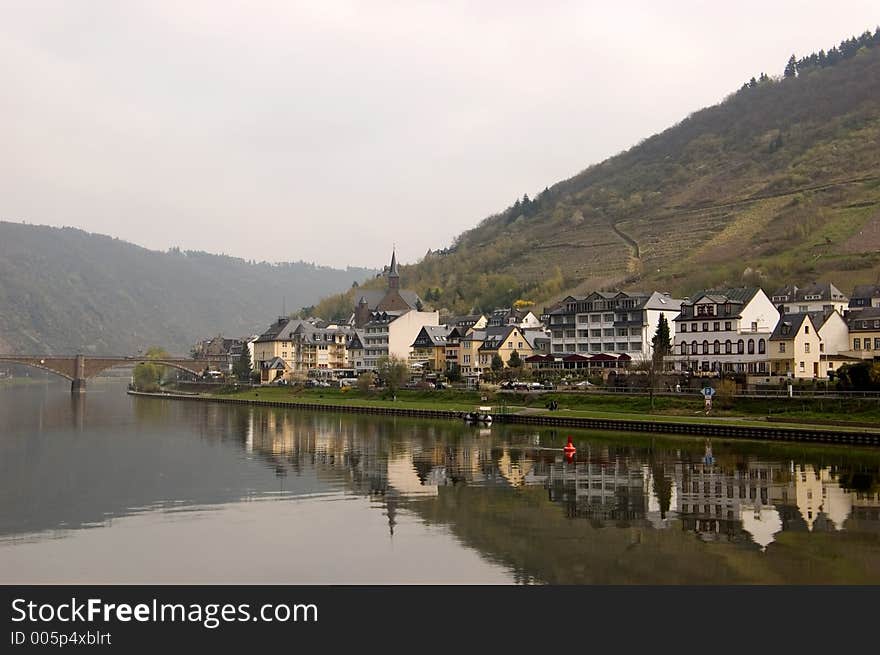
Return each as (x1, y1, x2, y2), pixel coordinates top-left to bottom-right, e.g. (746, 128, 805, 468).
(199, 387, 880, 431)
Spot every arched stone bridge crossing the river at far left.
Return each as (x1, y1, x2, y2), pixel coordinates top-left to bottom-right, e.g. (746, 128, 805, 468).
(0, 355, 217, 393)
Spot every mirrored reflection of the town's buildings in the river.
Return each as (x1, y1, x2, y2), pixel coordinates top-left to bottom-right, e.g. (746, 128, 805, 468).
(242, 408, 880, 550)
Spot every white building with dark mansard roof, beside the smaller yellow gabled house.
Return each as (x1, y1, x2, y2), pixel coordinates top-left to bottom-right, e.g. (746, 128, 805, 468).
(672, 287, 779, 375)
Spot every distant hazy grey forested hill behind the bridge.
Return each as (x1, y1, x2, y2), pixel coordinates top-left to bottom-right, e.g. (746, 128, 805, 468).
(0, 222, 375, 354)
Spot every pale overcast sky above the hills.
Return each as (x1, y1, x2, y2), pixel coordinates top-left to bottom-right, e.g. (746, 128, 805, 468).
(0, 0, 880, 267)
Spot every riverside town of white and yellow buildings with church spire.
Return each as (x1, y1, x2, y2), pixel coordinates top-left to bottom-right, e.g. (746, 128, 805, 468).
(192, 253, 880, 388)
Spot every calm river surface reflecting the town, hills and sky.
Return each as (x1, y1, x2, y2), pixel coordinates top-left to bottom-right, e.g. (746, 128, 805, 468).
(0, 382, 880, 584)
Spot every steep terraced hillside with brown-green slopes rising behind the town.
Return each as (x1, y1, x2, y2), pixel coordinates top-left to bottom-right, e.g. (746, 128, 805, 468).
(362, 31, 880, 312)
